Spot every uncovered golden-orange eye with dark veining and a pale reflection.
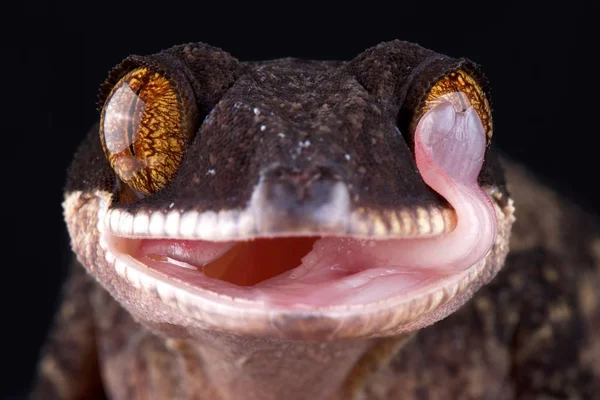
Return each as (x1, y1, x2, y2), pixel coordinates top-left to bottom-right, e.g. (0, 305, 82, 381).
(100, 67, 193, 195)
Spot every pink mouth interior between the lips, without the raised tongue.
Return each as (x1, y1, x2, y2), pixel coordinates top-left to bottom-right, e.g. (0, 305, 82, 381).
(109, 236, 451, 308)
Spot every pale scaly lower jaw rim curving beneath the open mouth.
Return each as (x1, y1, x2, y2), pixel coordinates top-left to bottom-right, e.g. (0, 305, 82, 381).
(63, 185, 513, 340)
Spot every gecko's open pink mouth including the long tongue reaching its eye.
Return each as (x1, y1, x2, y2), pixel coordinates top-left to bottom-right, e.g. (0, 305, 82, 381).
(105, 94, 496, 309)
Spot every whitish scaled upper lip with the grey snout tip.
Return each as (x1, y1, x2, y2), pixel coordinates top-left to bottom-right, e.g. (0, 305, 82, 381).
(104, 179, 456, 241)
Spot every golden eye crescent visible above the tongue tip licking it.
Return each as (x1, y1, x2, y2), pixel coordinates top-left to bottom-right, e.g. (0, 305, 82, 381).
(412, 69, 493, 143)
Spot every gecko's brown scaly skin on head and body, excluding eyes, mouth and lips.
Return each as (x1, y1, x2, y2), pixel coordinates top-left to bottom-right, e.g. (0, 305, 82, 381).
(35, 41, 600, 400)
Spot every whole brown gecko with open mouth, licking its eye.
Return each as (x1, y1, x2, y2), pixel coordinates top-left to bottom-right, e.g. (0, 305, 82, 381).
(32, 40, 600, 400)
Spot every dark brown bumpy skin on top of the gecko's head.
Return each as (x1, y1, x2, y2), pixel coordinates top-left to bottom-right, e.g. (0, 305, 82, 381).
(66, 41, 508, 217)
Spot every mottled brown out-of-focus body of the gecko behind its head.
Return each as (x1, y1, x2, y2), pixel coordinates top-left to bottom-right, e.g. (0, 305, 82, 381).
(32, 164, 600, 399)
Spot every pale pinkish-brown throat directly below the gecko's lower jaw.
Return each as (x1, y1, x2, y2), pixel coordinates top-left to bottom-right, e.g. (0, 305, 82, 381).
(168, 331, 396, 400)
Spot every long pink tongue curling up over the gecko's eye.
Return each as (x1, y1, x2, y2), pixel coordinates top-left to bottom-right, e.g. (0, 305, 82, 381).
(303, 93, 496, 274)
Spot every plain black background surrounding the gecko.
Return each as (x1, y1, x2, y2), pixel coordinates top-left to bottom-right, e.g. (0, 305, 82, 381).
(9, 0, 600, 397)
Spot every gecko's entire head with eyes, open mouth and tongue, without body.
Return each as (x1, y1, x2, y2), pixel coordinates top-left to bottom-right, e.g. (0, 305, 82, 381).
(63, 41, 513, 340)
